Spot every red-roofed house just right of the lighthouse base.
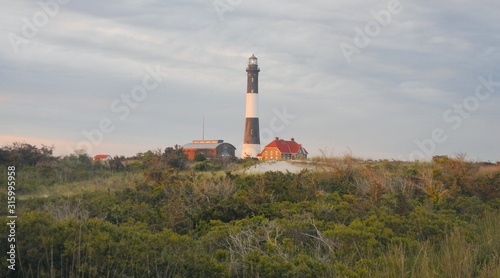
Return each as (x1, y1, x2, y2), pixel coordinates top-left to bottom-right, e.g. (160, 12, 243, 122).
(257, 137, 308, 160)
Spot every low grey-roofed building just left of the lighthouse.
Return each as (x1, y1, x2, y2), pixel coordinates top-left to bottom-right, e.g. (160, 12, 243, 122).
(182, 140, 236, 160)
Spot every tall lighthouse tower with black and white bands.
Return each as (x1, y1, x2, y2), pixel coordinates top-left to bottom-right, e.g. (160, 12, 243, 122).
(241, 54, 260, 158)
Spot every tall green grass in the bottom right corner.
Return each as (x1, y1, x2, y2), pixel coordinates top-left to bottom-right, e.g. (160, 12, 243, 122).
(372, 211, 500, 278)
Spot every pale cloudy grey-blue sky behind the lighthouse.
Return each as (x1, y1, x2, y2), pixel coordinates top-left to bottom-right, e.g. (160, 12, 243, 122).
(0, 0, 500, 162)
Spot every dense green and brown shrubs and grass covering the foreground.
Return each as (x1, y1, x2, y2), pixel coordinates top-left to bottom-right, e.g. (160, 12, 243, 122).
(0, 145, 500, 277)
